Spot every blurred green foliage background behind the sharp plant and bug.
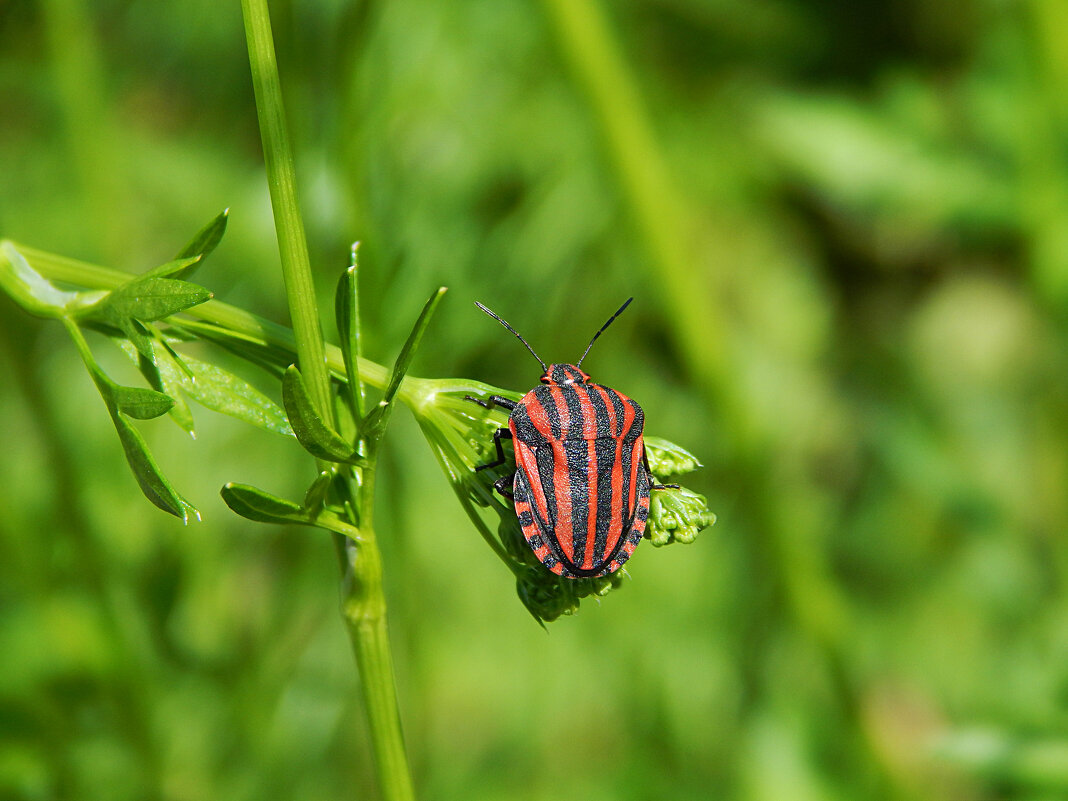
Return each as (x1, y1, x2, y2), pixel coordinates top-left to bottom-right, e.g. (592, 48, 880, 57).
(0, 0, 1068, 801)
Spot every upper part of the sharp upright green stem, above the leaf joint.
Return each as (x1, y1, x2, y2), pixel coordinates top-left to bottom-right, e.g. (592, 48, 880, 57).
(241, 0, 335, 423)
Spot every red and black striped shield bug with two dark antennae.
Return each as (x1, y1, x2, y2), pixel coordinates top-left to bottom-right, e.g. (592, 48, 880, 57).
(467, 298, 668, 579)
